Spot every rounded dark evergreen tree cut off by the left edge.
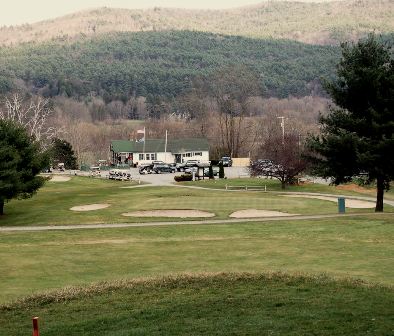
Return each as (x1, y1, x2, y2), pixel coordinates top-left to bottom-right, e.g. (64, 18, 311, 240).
(0, 120, 48, 215)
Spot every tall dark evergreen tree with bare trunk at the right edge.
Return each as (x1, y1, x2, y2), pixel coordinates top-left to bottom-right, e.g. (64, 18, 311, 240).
(309, 35, 394, 212)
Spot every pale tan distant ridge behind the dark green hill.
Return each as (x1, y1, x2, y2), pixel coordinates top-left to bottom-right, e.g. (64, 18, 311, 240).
(0, 0, 394, 45)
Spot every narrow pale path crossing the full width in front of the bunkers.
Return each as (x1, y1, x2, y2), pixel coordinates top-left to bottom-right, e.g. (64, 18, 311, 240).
(0, 213, 394, 233)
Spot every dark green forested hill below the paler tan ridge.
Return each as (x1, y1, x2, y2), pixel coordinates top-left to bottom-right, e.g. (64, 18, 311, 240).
(0, 31, 339, 102)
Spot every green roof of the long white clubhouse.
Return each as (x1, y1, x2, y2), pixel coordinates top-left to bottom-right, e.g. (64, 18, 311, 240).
(111, 138, 209, 154)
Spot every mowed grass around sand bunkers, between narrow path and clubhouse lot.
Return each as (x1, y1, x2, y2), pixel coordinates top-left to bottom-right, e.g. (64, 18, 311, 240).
(0, 177, 384, 226)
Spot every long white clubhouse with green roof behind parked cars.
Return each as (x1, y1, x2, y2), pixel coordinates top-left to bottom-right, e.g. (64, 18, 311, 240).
(110, 138, 209, 165)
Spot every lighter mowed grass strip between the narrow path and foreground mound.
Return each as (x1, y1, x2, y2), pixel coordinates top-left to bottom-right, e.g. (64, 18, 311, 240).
(0, 214, 394, 302)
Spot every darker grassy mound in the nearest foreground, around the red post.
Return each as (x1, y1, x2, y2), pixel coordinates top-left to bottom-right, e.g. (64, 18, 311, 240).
(0, 274, 394, 336)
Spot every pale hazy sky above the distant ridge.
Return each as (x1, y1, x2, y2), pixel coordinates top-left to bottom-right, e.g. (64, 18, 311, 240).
(0, 0, 264, 26)
